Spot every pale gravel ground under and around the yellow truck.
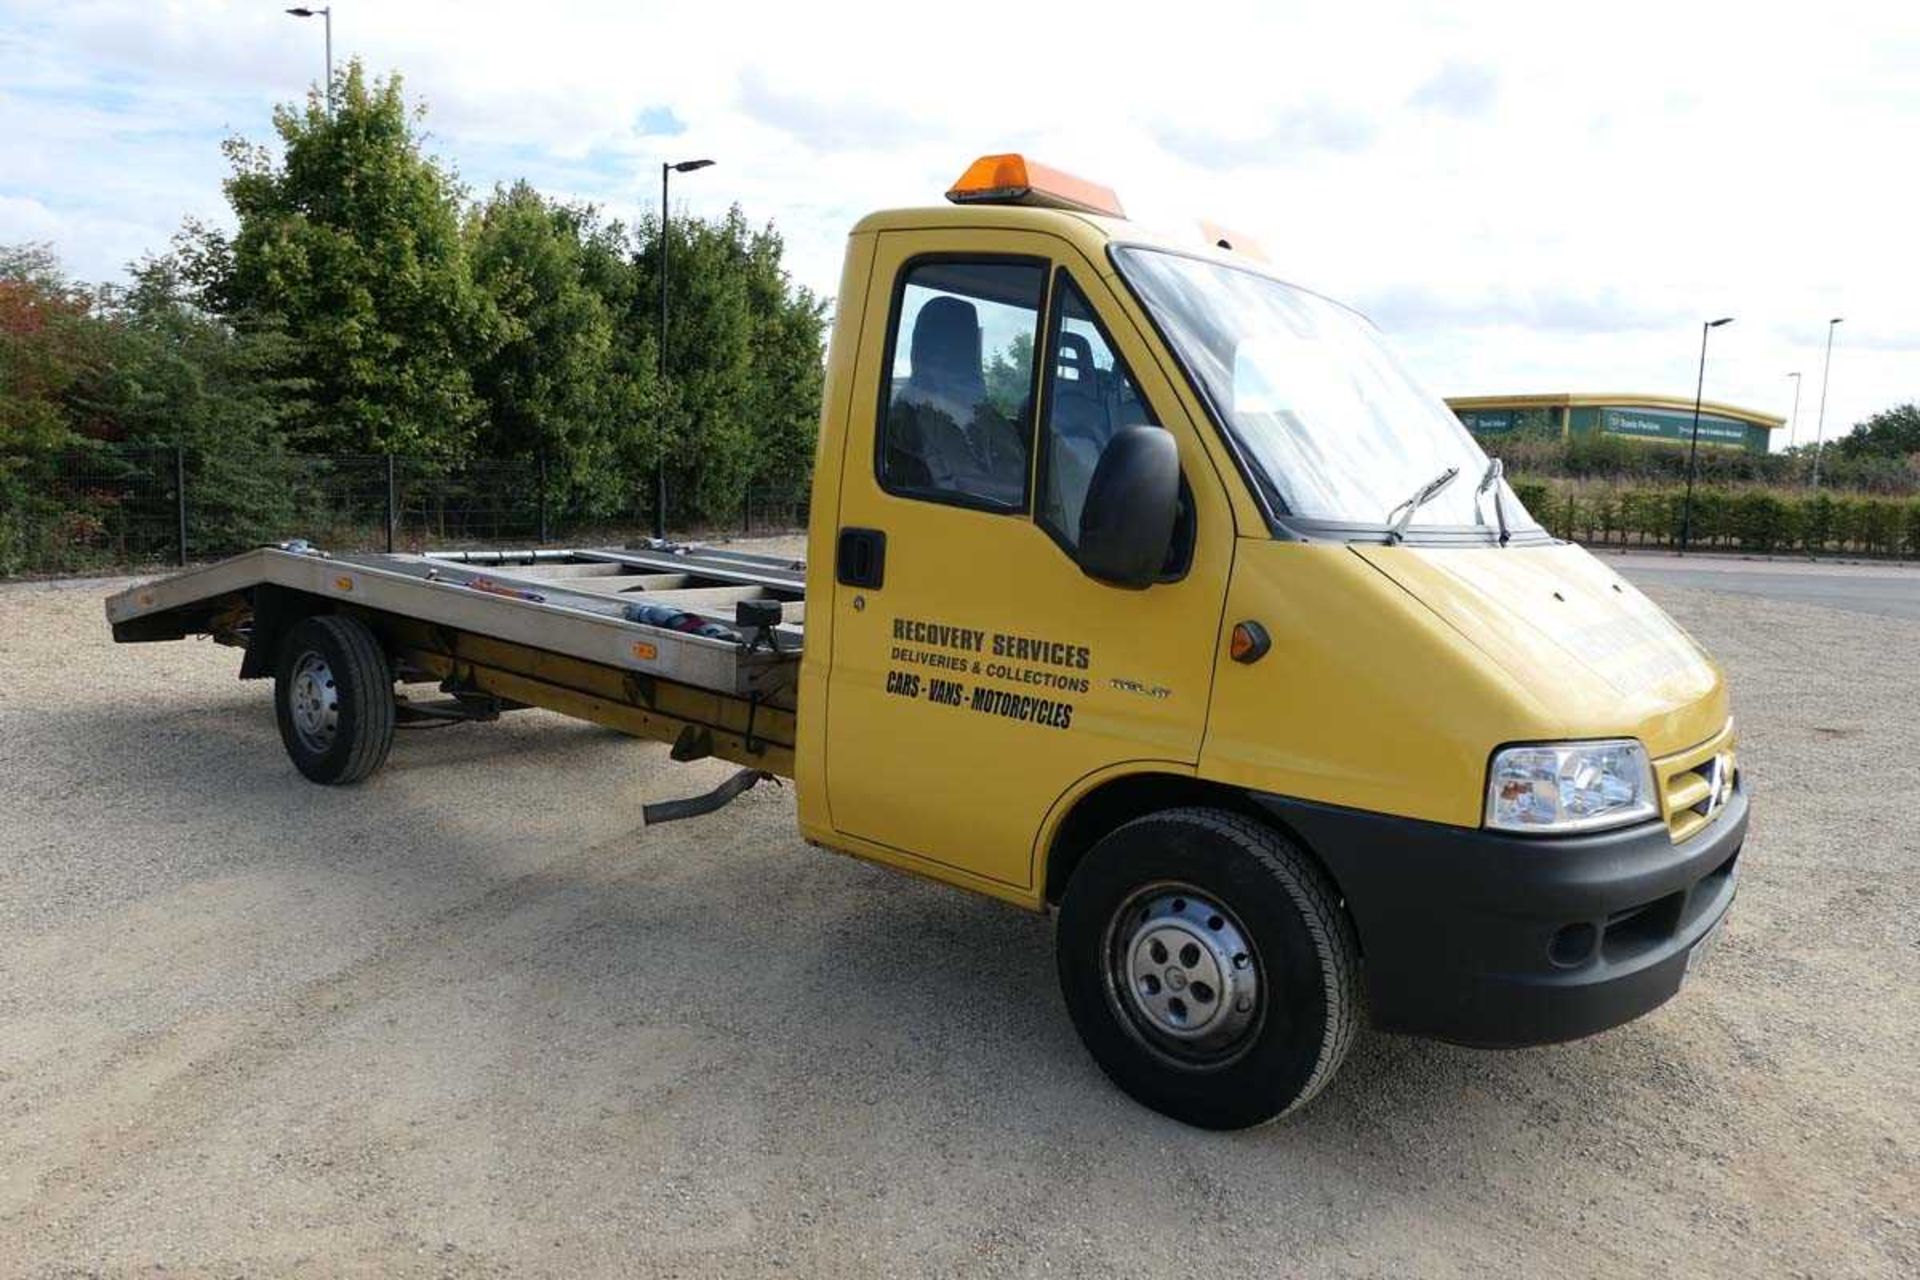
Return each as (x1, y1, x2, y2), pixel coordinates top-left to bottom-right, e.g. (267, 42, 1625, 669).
(0, 556, 1920, 1280)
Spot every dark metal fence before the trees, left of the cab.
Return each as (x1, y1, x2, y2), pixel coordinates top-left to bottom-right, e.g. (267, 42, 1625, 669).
(0, 445, 808, 576)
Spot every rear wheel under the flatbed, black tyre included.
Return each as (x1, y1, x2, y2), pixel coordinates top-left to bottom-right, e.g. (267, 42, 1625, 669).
(273, 614, 394, 787)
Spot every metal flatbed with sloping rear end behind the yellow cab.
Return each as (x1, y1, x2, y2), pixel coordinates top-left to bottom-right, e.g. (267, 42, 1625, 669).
(106, 543, 806, 775)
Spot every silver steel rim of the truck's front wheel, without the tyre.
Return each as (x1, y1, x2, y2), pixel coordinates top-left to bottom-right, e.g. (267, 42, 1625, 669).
(1102, 881, 1265, 1067)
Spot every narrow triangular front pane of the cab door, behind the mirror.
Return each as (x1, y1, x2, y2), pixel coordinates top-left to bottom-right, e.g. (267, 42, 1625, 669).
(1039, 273, 1160, 547)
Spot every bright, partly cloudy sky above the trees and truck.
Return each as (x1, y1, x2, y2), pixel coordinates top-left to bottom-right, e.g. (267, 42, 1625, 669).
(0, 0, 1920, 443)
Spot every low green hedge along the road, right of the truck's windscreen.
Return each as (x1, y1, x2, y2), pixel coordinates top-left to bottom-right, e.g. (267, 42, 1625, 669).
(1513, 478, 1920, 557)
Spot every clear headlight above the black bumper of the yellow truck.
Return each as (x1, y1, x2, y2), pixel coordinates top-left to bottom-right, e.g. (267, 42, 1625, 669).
(1486, 739, 1661, 835)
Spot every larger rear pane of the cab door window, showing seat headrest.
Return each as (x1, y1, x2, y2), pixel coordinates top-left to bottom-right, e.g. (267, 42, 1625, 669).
(879, 259, 1046, 510)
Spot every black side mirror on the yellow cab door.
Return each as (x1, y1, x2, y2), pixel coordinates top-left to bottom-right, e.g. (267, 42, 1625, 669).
(1079, 426, 1181, 589)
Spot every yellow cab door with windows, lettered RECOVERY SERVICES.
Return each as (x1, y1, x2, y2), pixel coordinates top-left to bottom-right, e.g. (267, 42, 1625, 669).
(826, 228, 1233, 889)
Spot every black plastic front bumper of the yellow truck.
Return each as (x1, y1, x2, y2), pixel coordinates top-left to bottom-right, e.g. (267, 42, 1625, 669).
(1252, 785, 1747, 1046)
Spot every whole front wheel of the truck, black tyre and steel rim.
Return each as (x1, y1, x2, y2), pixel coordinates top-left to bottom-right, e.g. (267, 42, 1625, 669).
(1054, 808, 1361, 1128)
